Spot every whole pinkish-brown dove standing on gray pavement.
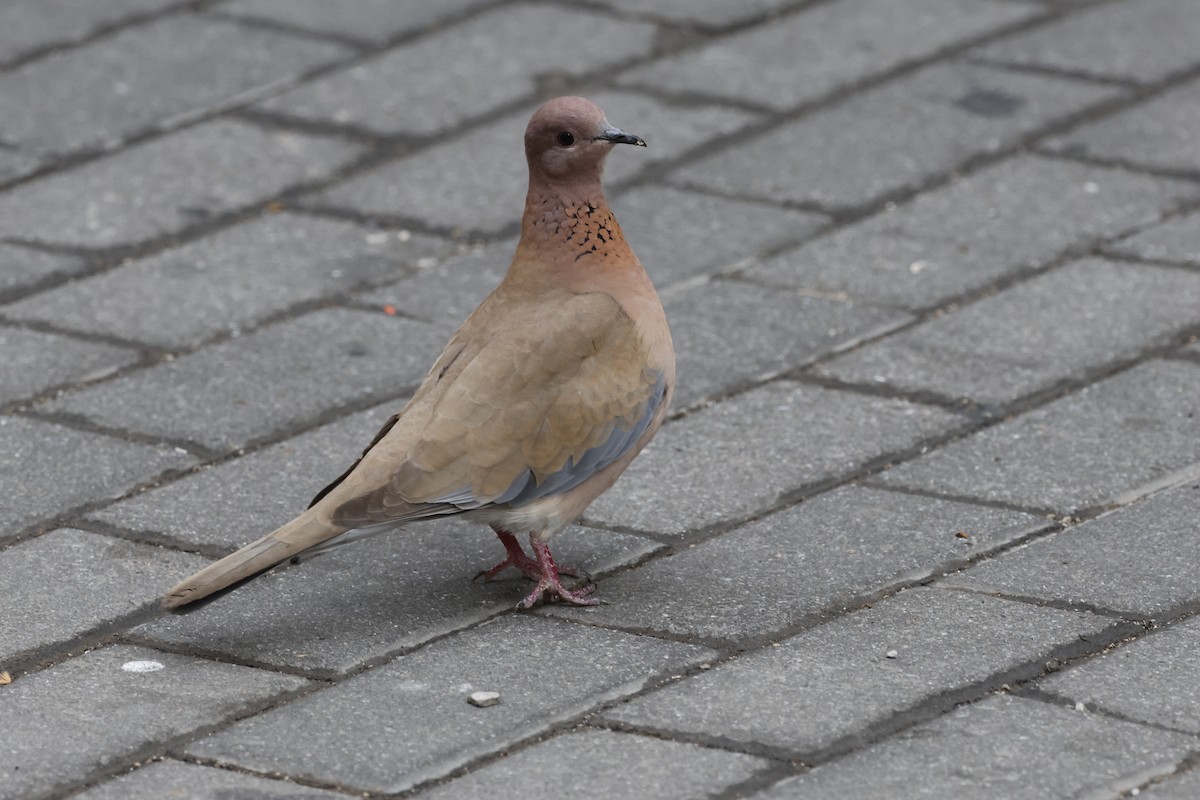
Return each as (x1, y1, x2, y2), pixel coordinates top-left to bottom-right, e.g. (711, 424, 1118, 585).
(163, 97, 674, 608)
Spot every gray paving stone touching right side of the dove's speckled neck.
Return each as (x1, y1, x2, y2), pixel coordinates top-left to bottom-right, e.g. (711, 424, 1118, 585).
(612, 186, 826, 289)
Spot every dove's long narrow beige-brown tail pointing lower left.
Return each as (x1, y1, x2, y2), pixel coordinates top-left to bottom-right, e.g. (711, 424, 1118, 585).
(162, 509, 348, 608)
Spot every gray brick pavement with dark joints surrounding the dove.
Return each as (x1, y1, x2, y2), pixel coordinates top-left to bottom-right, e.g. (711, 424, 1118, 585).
(0, 0, 1200, 800)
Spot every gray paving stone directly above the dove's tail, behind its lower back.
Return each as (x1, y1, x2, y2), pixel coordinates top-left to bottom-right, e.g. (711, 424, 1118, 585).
(88, 399, 406, 553)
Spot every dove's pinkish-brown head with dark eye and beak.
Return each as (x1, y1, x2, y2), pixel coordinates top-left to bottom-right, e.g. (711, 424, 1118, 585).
(526, 97, 646, 185)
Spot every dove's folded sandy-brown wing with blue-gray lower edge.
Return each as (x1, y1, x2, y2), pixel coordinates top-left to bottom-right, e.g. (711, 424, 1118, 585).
(333, 294, 664, 524)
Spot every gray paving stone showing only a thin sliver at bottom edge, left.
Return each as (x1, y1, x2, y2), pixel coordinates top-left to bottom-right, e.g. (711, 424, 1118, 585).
(72, 760, 346, 800)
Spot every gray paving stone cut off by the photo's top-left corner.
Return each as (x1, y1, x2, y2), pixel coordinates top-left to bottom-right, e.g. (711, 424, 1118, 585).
(0, 0, 180, 62)
